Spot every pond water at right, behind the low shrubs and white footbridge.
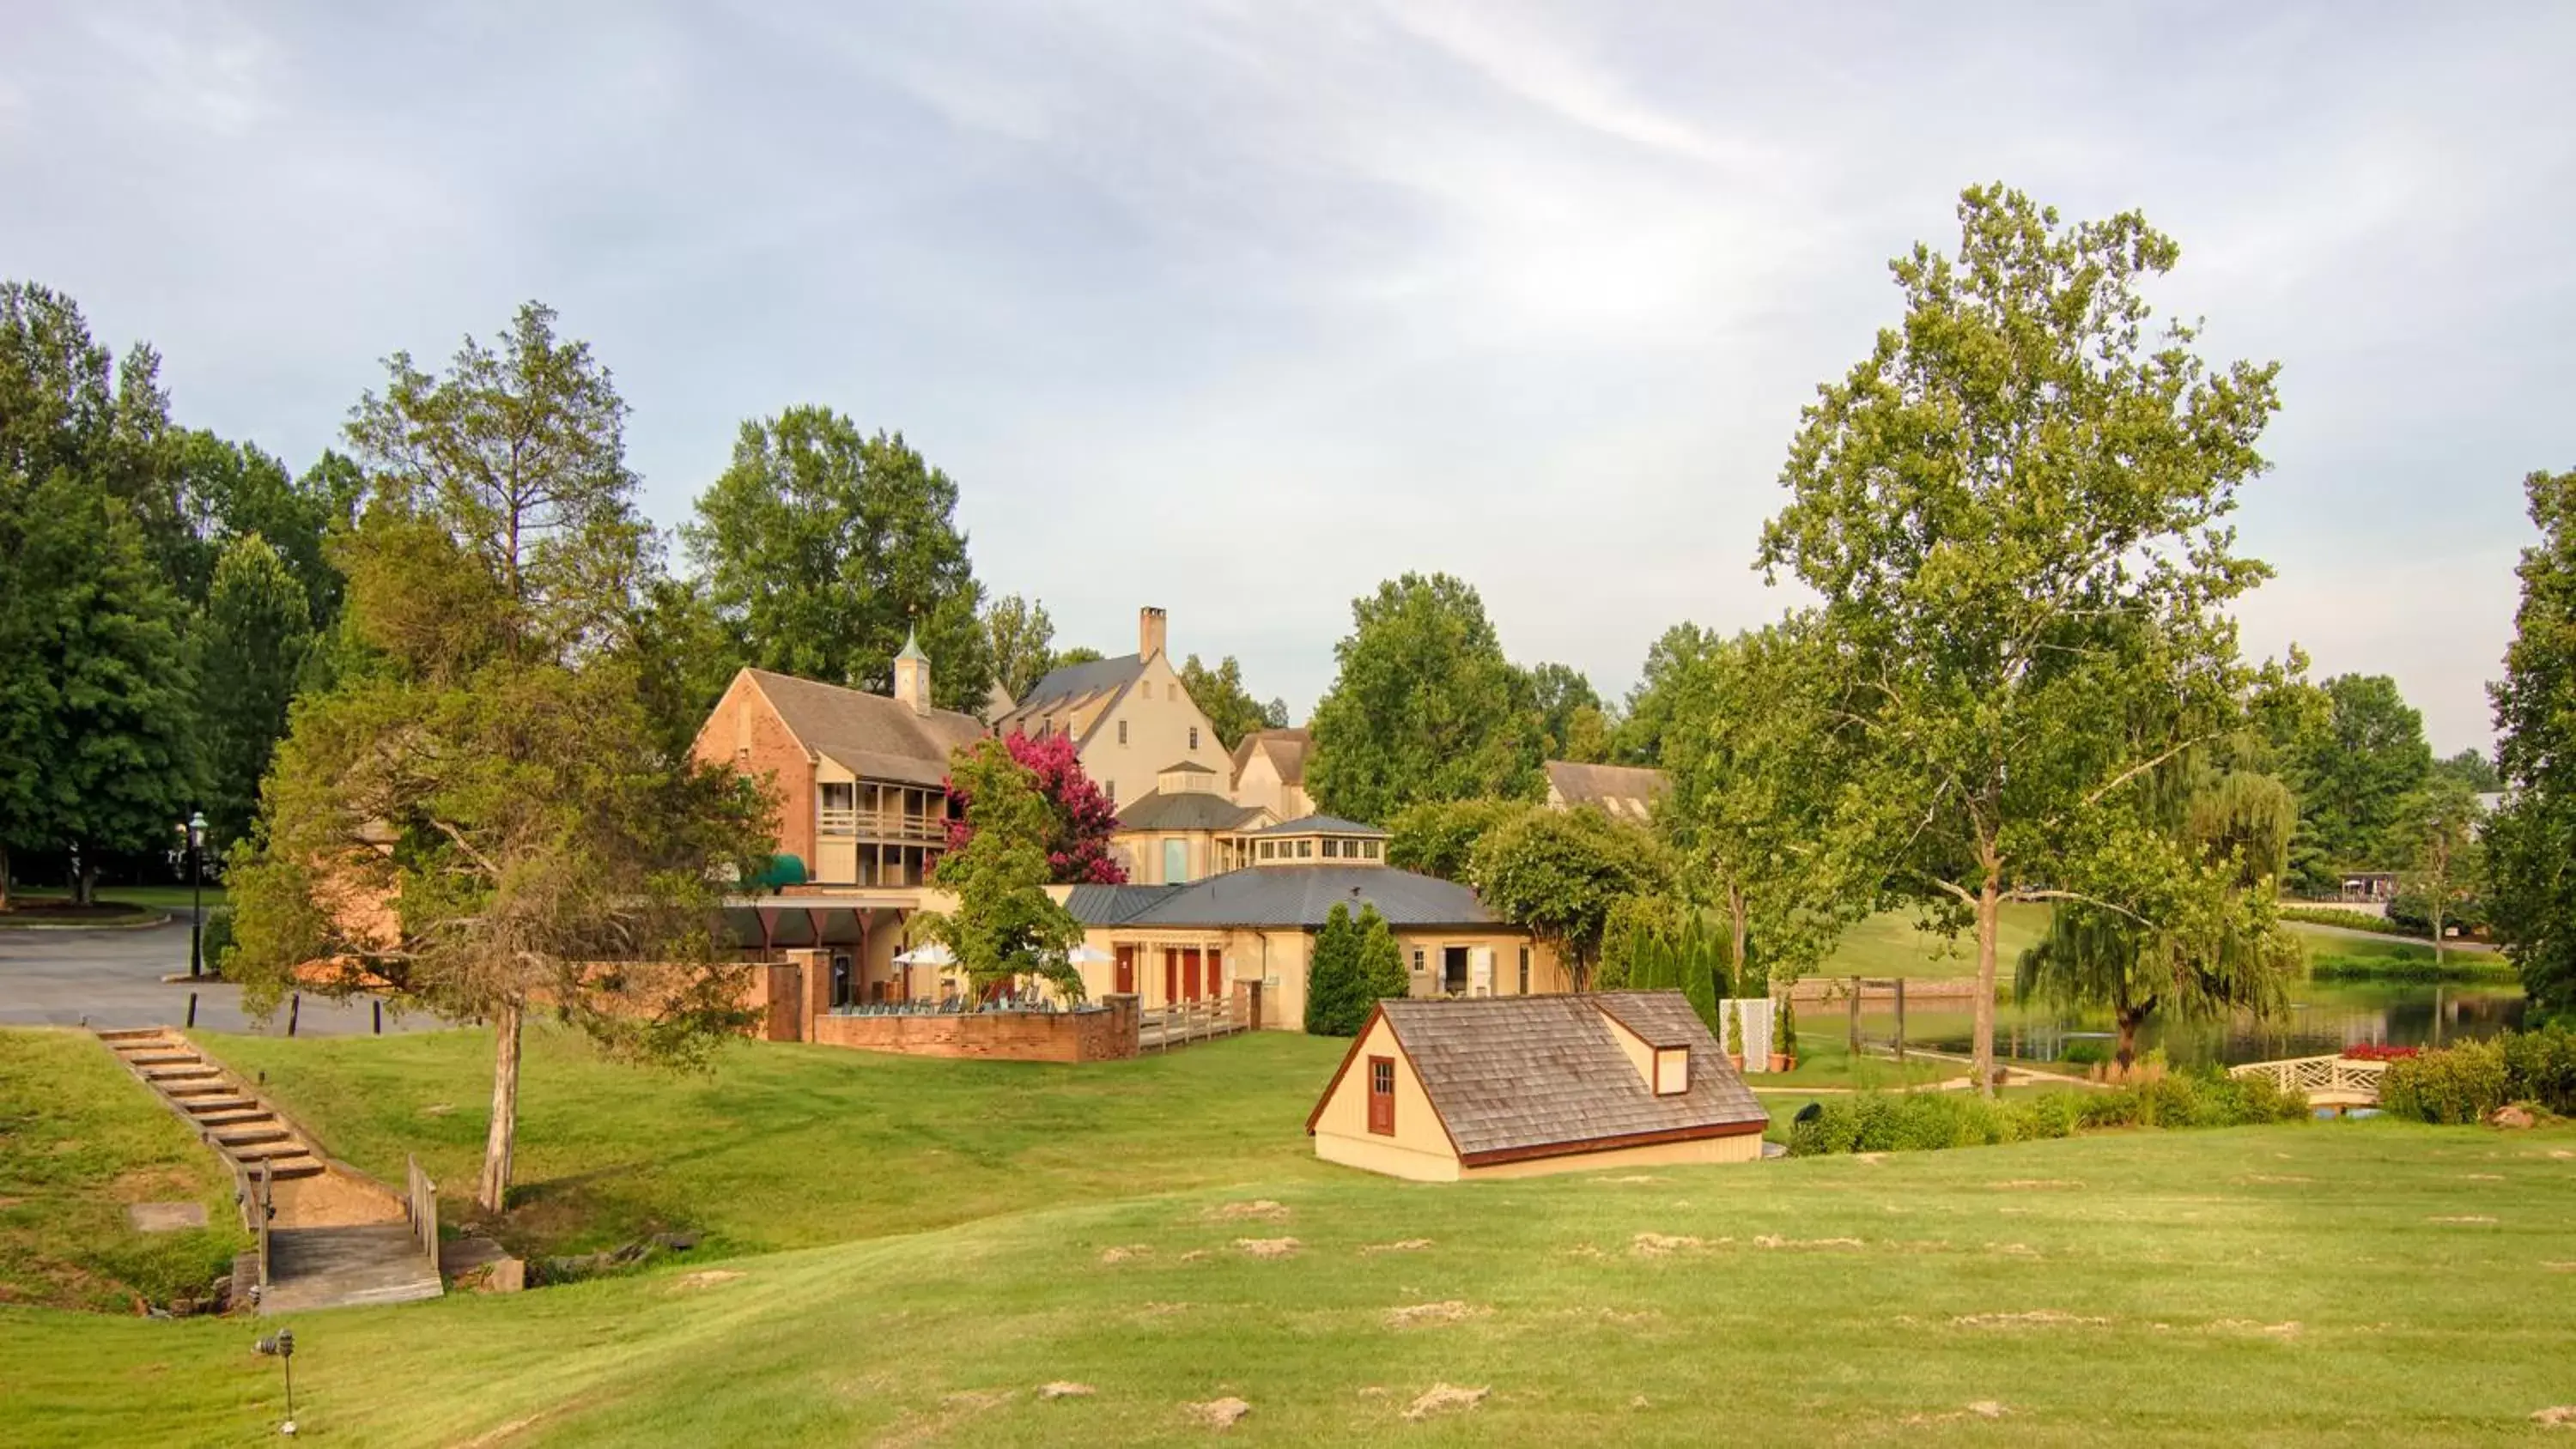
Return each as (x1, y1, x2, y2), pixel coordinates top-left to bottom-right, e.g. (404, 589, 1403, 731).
(1896, 980, 2522, 1065)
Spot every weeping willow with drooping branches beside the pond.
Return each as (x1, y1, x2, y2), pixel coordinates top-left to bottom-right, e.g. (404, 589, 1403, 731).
(2014, 741, 2298, 1070)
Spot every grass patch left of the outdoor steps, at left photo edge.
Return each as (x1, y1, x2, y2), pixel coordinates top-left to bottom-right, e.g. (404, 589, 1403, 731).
(0, 1029, 250, 1313)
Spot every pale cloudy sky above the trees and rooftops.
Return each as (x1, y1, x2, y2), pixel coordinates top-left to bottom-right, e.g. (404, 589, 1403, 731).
(0, 0, 2576, 754)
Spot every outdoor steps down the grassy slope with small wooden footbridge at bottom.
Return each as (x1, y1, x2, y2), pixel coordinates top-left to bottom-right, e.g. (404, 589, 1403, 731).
(98, 1027, 443, 1313)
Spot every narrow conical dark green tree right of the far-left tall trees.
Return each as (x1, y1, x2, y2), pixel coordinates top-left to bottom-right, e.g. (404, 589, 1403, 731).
(196, 533, 314, 846)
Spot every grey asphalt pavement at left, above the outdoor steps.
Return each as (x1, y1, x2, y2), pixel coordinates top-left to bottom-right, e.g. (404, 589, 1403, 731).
(0, 911, 443, 1037)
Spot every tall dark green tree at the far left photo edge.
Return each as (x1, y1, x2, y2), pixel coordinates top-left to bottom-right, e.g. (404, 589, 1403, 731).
(0, 283, 196, 903)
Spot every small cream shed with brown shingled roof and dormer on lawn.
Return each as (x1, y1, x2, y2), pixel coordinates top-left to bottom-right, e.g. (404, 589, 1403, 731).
(1306, 991, 1770, 1181)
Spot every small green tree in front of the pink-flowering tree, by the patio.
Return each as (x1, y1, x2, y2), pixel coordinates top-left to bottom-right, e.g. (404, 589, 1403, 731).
(914, 738, 1082, 1001)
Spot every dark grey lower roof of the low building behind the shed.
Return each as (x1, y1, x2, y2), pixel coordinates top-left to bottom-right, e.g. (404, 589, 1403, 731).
(1064, 864, 1494, 929)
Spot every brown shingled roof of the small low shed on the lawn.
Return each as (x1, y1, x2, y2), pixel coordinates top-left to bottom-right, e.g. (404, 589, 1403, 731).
(1306, 991, 1770, 1166)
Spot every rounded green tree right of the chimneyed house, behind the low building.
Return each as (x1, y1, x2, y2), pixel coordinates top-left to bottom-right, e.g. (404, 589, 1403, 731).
(1306, 574, 1543, 821)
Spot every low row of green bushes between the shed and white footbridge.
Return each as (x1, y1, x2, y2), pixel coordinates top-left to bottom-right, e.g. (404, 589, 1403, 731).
(1788, 1073, 2308, 1158)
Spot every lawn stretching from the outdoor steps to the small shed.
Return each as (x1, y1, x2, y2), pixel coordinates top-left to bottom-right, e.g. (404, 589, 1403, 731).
(201, 1029, 1347, 1256)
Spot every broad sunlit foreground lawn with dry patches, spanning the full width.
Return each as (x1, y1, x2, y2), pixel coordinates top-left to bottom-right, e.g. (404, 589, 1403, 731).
(0, 1112, 2576, 1446)
